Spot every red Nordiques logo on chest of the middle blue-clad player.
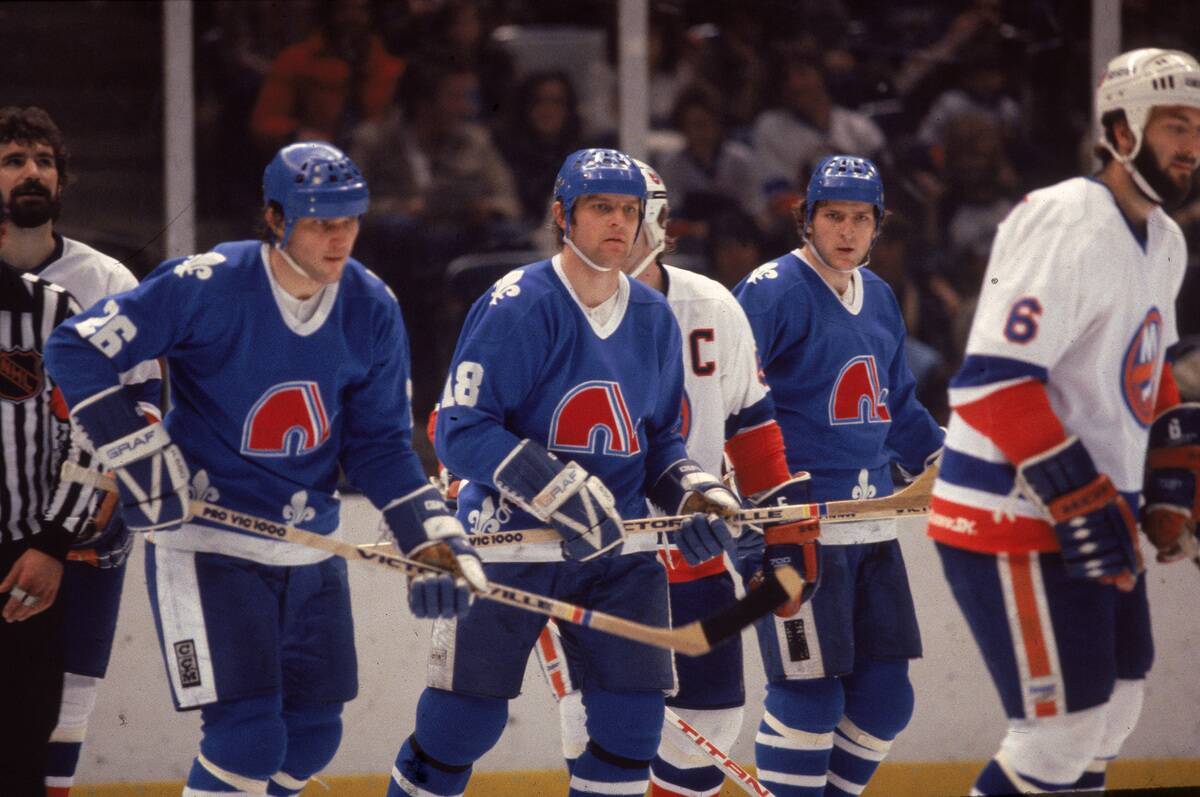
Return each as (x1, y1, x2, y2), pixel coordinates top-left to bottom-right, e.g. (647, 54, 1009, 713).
(547, 379, 642, 456)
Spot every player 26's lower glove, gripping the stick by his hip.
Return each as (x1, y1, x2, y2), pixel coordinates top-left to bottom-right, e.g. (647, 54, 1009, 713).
(382, 485, 487, 618)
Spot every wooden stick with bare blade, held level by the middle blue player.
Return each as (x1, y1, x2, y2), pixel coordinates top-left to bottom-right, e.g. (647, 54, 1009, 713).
(408, 466, 937, 547)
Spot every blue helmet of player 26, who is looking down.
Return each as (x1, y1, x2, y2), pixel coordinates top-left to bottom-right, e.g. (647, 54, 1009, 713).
(263, 142, 370, 246)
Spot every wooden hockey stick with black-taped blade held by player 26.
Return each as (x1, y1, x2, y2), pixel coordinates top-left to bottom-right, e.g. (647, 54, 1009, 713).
(62, 461, 804, 655)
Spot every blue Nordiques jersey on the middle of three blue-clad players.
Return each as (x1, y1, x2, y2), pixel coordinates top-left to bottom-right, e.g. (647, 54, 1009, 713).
(437, 258, 686, 547)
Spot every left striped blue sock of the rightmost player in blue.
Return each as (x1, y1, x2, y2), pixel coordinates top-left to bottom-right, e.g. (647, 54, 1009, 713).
(755, 678, 844, 797)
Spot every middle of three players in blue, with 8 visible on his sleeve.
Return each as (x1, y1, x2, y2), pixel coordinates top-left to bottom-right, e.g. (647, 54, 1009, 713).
(388, 149, 737, 797)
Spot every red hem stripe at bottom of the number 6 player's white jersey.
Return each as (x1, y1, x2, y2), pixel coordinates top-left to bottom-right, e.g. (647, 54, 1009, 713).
(926, 496, 1058, 553)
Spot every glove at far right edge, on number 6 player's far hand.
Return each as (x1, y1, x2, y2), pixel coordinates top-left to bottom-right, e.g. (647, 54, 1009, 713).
(1142, 402, 1200, 562)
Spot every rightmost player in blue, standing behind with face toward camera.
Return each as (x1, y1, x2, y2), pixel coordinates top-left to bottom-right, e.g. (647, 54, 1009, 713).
(734, 155, 942, 797)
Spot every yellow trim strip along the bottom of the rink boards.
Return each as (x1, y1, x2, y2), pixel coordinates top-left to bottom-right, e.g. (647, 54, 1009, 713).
(71, 759, 1200, 797)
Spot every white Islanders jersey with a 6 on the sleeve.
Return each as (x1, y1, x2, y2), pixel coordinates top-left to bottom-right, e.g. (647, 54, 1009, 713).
(930, 178, 1187, 550)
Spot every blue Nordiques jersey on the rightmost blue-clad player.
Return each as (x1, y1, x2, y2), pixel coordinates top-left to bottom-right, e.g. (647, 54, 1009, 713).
(733, 251, 942, 501)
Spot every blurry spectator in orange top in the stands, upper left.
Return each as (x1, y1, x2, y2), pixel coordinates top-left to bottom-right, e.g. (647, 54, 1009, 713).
(250, 0, 404, 150)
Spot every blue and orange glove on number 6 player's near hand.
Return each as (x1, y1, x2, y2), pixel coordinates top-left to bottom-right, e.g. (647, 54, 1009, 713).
(1016, 437, 1142, 592)
